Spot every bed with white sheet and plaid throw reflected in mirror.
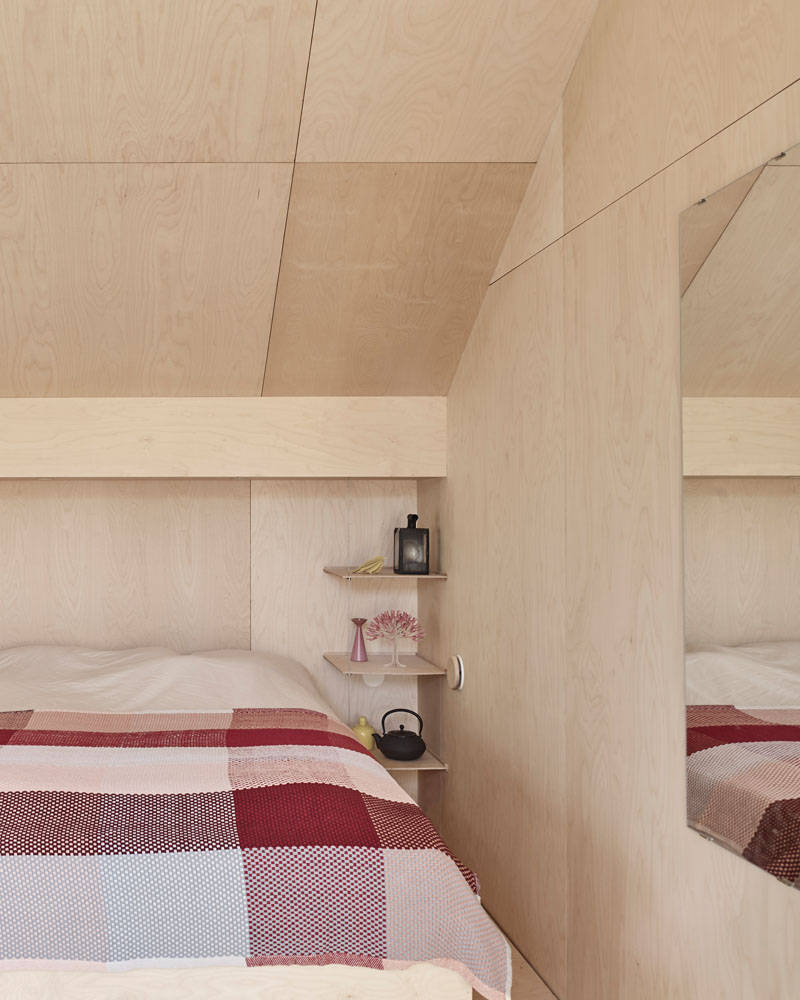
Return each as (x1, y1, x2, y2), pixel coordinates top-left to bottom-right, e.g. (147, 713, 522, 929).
(686, 641, 800, 888)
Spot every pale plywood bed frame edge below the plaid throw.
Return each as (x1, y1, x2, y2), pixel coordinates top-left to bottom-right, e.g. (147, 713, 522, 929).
(3, 962, 472, 1000)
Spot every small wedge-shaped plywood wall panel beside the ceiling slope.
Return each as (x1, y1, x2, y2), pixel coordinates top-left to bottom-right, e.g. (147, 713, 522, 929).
(492, 104, 564, 282)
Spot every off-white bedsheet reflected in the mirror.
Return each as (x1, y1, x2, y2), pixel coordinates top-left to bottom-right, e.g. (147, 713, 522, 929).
(686, 640, 800, 708)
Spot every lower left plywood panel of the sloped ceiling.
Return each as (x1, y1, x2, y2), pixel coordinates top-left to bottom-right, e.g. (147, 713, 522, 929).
(0, 164, 291, 396)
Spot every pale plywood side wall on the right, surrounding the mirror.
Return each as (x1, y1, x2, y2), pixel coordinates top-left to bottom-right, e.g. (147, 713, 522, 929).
(420, 0, 800, 1000)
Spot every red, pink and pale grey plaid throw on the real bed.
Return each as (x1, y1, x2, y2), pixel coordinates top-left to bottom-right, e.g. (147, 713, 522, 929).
(0, 709, 510, 1000)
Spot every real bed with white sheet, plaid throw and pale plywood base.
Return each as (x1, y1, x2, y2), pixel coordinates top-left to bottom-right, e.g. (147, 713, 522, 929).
(0, 646, 510, 1000)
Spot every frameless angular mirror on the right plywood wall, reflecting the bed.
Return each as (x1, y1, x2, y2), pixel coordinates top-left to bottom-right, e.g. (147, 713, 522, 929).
(680, 146, 800, 888)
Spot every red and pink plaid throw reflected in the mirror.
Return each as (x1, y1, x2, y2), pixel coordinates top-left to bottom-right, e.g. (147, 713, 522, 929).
(686, 705, 800, 888)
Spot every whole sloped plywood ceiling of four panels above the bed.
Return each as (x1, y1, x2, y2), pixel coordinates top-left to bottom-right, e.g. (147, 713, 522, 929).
(0, 0, 596, 396)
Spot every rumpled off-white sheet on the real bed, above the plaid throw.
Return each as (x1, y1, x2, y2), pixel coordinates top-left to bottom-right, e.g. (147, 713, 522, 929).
(0, 646, 335, 717)
